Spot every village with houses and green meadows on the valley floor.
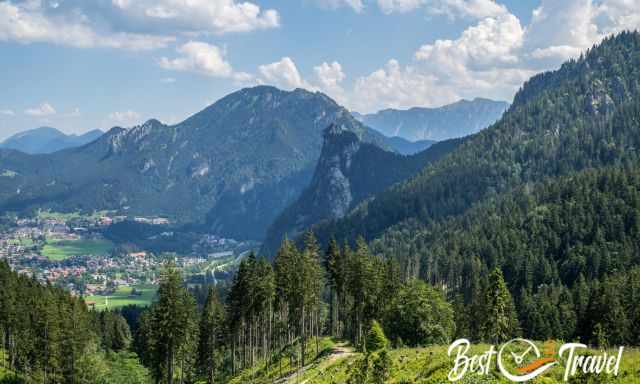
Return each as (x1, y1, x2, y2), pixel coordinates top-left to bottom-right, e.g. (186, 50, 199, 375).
(0, 213, 255, 306)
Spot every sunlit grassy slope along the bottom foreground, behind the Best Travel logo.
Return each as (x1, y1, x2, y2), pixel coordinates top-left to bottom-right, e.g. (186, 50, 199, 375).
(231, 339, 640, 384)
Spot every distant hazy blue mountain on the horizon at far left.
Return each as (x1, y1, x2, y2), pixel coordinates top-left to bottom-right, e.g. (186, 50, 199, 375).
(0, 127, 104, 154)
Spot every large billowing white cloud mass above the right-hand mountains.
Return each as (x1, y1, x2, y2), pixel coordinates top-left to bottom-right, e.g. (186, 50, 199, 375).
(348, 0, 640, 112)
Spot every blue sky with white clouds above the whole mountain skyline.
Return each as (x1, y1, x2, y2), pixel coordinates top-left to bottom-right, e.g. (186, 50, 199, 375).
(0, 0, 640, 140)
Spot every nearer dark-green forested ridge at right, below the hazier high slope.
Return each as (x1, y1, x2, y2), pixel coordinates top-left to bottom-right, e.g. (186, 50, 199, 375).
(372, 164, 640, 345)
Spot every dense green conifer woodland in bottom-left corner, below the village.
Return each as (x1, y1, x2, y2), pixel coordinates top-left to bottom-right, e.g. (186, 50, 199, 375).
(0, 262, 149, 384)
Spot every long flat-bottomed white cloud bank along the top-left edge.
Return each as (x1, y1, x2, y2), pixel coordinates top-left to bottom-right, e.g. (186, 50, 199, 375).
(0, 0, 279, 50)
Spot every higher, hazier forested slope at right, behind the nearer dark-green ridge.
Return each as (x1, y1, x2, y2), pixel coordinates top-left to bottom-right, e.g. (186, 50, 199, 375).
(316, 32, 640, 249)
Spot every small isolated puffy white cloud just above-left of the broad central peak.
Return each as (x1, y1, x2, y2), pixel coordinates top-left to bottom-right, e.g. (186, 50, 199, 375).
(158, 41, 251, 81)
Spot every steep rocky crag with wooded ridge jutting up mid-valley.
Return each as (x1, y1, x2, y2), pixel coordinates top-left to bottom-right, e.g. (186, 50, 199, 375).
(262, 125, 463, 255)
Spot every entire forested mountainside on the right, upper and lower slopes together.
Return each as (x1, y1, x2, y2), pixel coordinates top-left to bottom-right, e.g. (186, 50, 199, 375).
(290, 32, 640, 345)
